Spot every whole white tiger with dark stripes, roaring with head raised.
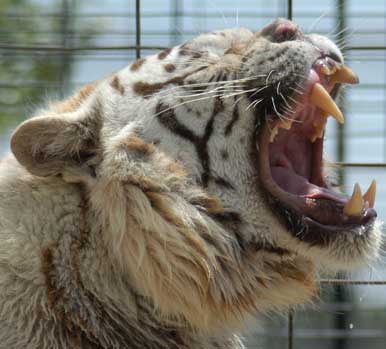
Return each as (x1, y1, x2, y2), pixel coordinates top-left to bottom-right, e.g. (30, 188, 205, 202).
(0, 19, 381, 349)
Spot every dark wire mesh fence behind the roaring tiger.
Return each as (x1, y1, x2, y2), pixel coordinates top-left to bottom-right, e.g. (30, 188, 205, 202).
(0, 0, 386, 349)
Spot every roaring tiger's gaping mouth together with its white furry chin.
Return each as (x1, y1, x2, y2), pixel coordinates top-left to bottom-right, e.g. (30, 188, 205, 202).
(255, 57, 381, 270)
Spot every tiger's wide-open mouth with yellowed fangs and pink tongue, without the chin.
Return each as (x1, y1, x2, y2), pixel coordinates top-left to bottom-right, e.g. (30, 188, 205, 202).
(257, 57, 377, 237)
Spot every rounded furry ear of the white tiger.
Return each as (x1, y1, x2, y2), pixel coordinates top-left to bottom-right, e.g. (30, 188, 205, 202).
(11, 107, 102, 177)
